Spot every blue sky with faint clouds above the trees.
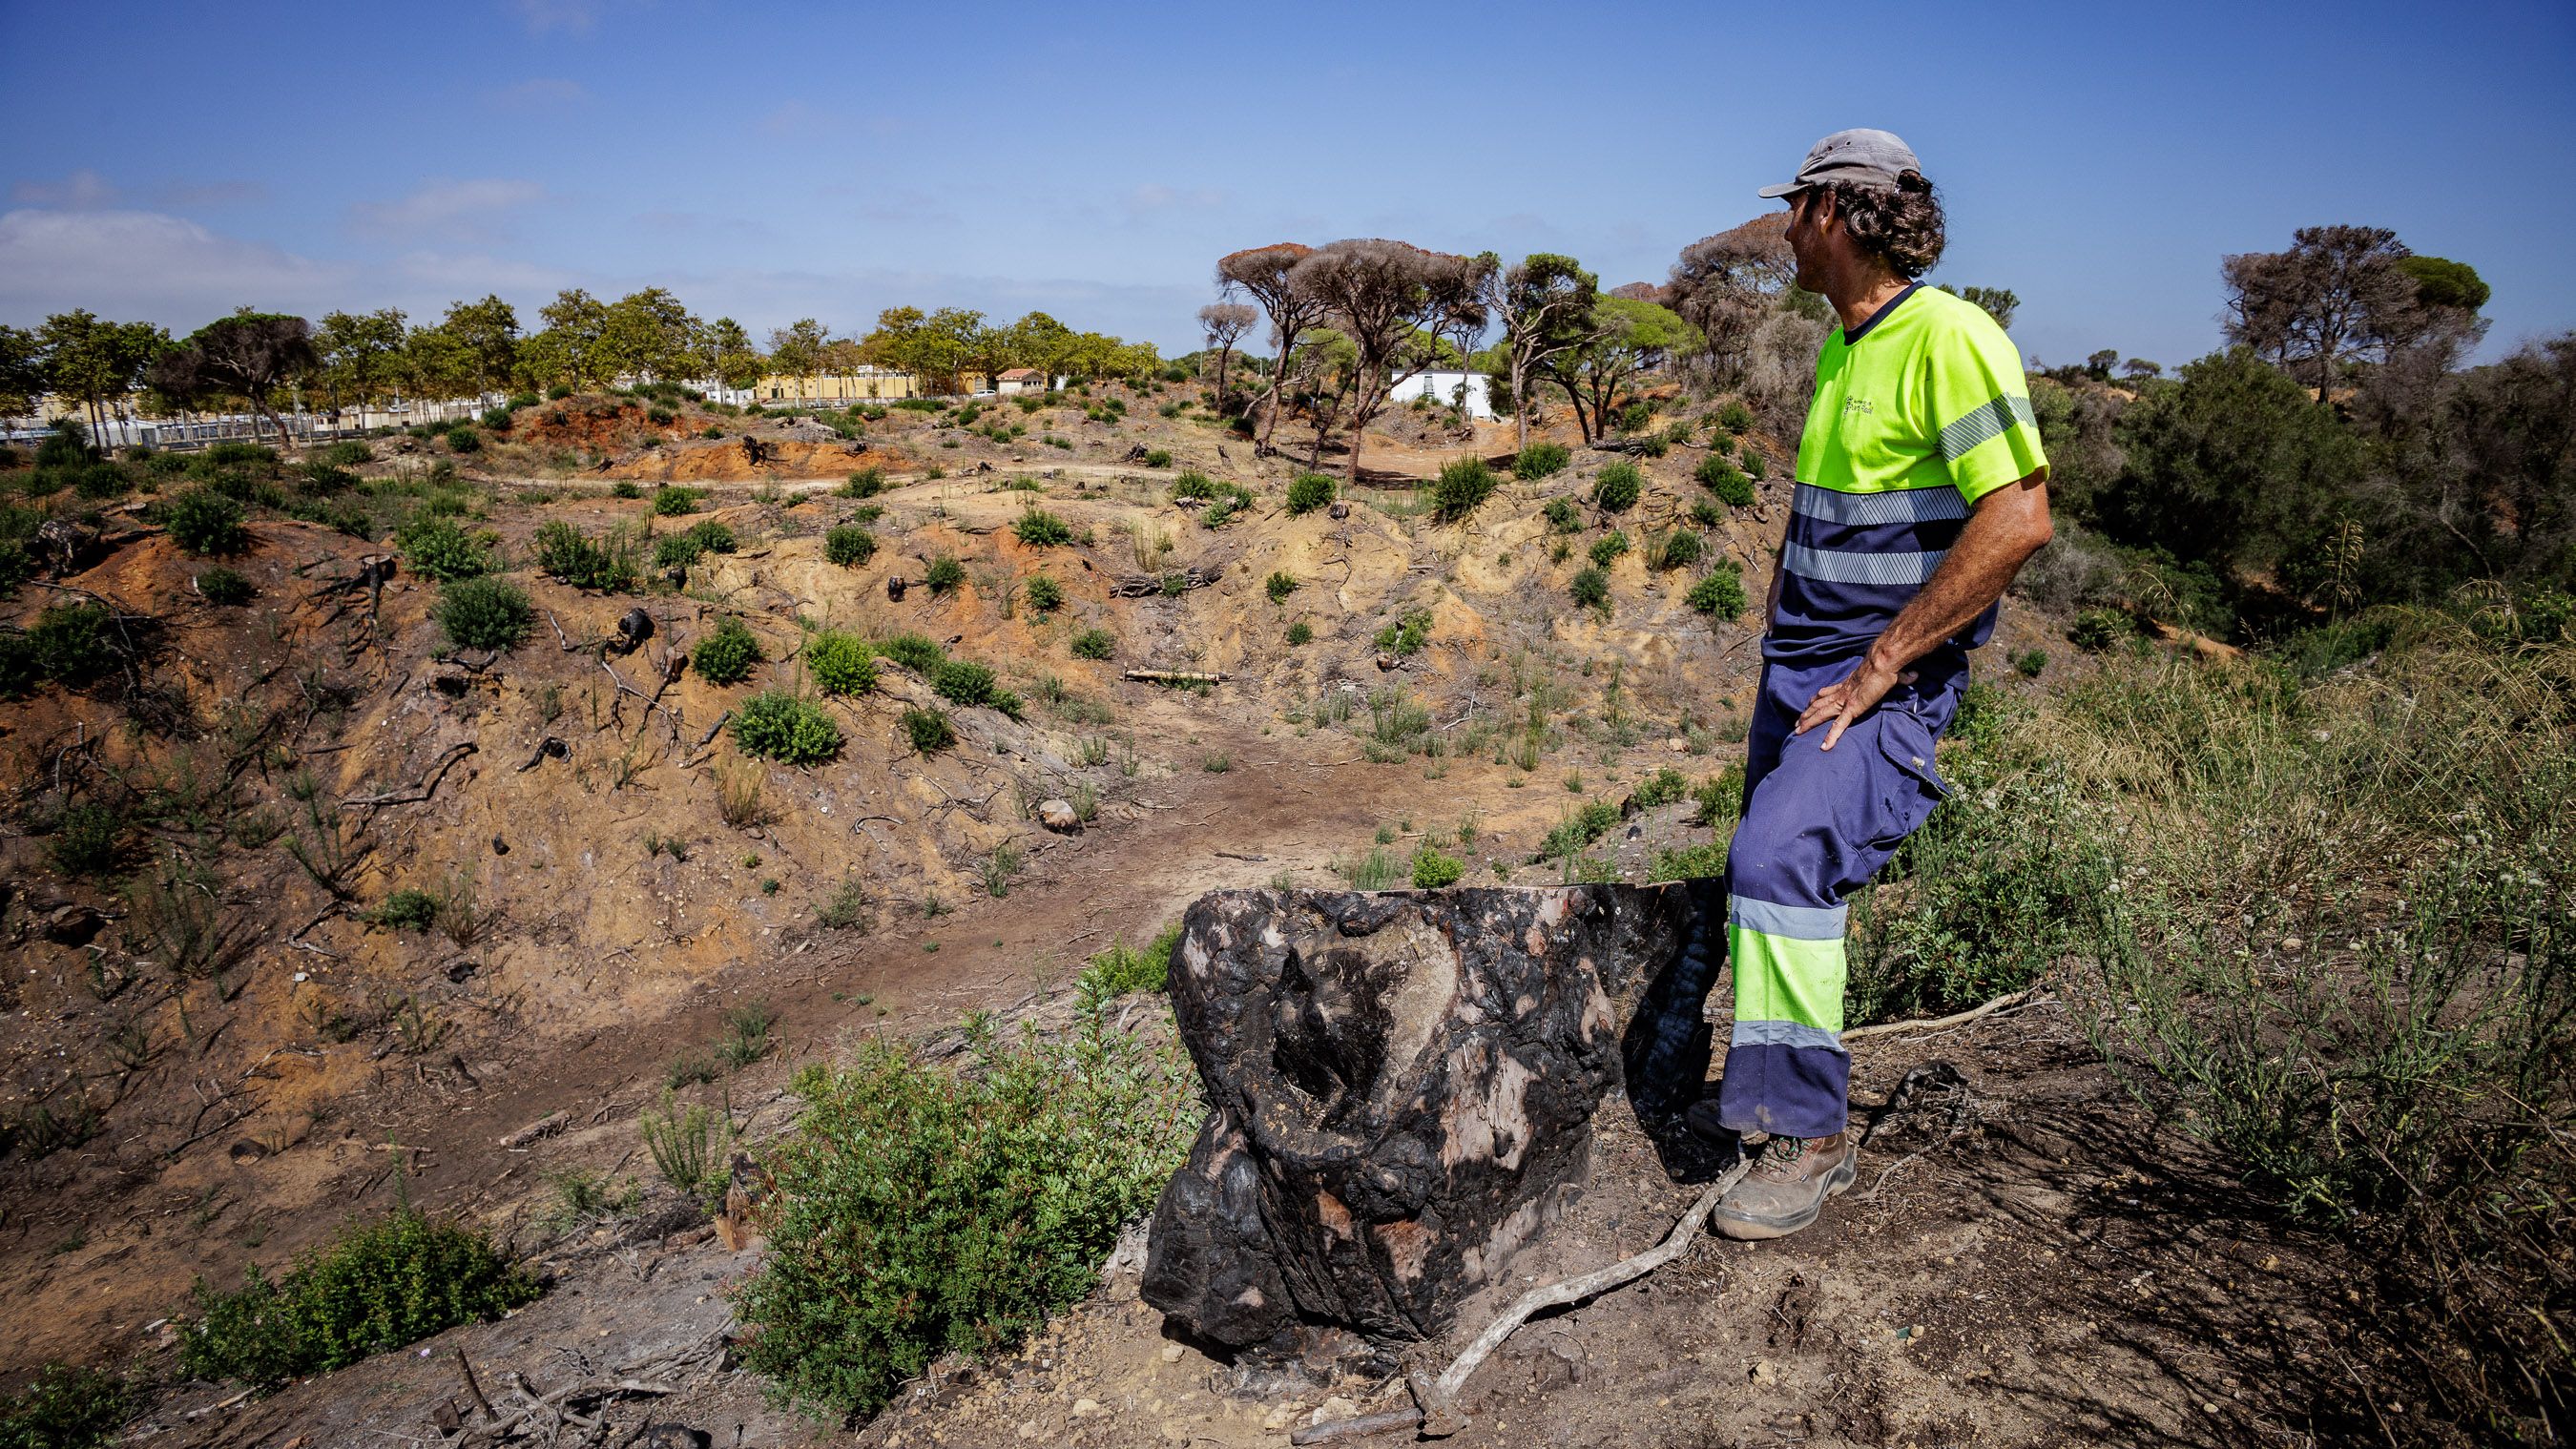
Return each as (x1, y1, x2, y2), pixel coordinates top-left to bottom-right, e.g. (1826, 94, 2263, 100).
(0, 0, 2576, 365)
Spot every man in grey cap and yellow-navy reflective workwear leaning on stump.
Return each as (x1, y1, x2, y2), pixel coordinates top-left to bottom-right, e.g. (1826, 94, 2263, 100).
(1693, 132, 2048, 1238)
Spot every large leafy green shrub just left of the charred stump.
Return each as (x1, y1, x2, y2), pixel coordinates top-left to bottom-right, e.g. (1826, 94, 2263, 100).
(735, 1014, 1200, 1416)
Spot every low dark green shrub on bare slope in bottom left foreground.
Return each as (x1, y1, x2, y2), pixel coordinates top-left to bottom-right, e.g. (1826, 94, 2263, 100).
(177, 1205, 538, 1387)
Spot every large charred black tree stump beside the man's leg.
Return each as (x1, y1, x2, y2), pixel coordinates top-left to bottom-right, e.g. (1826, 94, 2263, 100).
(1144, 882, 1726, 1346)
